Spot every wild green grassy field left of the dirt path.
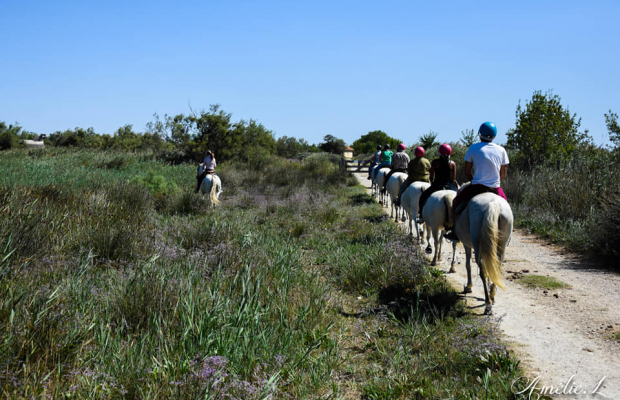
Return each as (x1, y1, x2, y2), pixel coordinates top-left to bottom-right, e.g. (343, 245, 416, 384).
(0, 148, 520, 399)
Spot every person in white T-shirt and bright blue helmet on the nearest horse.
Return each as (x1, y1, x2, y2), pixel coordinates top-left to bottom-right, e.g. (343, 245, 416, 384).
(444, 122, 509, 240)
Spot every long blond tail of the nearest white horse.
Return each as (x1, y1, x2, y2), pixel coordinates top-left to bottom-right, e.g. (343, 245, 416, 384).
(480, 202, 504, 289)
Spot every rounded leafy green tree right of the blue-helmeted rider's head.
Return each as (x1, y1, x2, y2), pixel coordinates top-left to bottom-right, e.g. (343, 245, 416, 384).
(507, 91, 590, 164)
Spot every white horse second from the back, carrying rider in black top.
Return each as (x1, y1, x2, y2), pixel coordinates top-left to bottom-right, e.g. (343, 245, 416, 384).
(422, 190, 456, 272)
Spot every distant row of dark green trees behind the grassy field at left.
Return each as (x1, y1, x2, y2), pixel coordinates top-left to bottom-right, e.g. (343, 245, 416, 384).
(0, 105, 354, 163)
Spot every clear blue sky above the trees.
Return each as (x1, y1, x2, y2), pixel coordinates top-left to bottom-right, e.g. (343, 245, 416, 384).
(0, 0, 620, 145)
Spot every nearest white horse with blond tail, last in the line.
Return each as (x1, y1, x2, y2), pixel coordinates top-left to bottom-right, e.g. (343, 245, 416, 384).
(455, 189, 513, 314)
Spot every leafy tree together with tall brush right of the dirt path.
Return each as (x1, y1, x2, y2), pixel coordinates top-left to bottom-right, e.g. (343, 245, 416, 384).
(502, 92, 620, 265)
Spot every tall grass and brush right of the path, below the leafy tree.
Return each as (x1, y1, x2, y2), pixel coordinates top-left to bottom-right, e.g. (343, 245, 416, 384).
(502, 149, 620, 257)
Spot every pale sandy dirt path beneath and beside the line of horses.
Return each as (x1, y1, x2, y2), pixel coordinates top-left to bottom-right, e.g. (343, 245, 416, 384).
(356, 174, 620, 399)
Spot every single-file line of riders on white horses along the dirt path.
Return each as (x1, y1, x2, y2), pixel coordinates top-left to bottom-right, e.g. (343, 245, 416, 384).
(368, 122, 513, 313)
